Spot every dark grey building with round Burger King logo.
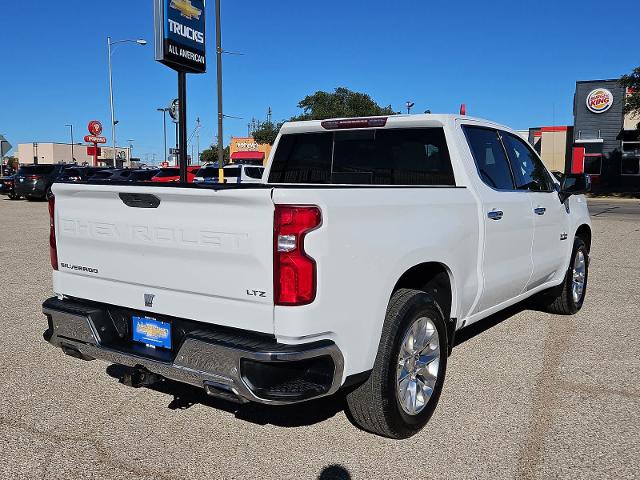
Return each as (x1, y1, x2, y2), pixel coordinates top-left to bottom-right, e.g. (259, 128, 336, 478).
(570, 79, 640, 190)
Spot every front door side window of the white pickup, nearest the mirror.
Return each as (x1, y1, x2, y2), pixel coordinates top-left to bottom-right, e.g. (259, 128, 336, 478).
(500, 132, 553, 192)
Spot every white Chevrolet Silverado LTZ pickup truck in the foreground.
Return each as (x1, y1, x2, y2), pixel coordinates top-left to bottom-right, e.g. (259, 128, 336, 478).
(43, 115, 591, 438)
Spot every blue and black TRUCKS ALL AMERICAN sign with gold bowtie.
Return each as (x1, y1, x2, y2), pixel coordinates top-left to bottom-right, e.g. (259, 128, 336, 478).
(155, 0, 207, 73)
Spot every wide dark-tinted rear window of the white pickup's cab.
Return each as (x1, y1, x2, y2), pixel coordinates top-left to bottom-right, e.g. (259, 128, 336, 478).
(269, 128, 455, 186)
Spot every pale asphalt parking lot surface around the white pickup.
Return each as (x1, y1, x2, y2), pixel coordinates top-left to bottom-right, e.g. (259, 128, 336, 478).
(0, 197, 640, 480)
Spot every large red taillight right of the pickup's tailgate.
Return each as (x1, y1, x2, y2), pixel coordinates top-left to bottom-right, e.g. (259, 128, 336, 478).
(273, 205, 322, 306)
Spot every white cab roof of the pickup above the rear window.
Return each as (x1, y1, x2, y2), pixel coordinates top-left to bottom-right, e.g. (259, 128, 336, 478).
(281, 113, 512, 134)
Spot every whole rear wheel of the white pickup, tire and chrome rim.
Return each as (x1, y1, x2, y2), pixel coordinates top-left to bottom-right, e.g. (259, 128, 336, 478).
(347, 289, 448, 438)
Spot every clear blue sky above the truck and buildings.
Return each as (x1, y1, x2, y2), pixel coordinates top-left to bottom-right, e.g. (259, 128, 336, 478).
(0, 0, 640, 159)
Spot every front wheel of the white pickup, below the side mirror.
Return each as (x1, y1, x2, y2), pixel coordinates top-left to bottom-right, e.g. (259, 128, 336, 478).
(546, 237, 589, 315)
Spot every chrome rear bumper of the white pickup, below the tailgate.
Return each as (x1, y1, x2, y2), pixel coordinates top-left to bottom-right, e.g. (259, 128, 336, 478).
(42, 297, 344, 405)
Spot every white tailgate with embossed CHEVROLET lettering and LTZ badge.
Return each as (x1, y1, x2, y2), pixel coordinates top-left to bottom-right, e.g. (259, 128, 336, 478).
(53, 184, 274, 333)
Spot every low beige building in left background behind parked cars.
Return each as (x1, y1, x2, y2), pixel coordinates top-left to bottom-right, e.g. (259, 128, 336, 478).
(18, 142, 131, 167)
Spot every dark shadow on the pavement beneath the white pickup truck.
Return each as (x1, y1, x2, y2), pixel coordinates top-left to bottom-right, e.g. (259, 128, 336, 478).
(106, 301, 542, 428)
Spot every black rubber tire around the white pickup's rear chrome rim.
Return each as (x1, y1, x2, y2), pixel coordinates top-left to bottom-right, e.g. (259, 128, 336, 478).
(347, 289, 448, 439)
